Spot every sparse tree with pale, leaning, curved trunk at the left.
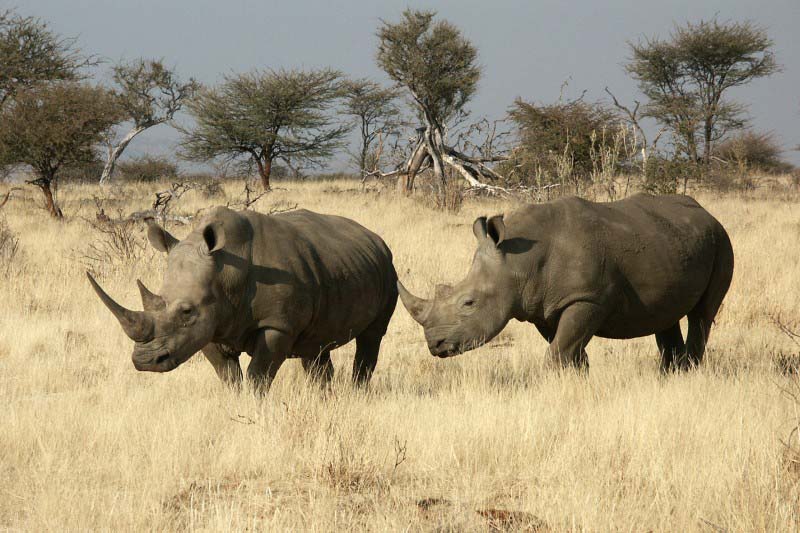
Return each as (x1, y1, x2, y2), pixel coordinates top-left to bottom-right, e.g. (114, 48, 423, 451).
(100, 59, 199, 184)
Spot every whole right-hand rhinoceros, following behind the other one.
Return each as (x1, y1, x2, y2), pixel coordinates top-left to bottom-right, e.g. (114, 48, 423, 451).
(398, 194, 733, 370)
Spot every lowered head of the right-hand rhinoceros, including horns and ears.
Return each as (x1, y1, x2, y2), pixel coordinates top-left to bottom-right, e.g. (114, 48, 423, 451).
(397, 215, 516, 357)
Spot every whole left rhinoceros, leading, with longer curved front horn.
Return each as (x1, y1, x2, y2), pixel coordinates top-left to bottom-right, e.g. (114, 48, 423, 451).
(87, 207, 397, 391)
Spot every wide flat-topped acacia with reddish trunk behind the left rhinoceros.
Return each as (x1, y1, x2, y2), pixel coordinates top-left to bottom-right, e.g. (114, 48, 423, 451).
(182, 69, 349, 190)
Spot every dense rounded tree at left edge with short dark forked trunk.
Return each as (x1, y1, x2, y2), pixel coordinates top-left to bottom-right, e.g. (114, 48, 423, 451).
(0, 82, 120, 218)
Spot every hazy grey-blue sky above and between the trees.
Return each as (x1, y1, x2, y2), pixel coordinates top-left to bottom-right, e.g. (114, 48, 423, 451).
(12, 0, 800, 167)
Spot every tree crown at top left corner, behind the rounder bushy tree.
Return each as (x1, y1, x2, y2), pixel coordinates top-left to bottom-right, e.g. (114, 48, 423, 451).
(0, 11, 96, 109)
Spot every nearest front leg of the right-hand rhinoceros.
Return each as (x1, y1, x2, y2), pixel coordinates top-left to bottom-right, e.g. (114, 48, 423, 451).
(547, 302, 605, 370)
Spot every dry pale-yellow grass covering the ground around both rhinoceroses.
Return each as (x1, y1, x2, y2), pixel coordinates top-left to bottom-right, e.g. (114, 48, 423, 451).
(0, 177, 800, 531)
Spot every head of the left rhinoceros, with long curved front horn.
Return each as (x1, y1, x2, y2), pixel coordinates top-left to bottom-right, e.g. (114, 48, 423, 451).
(87, 216, 230, 372)
